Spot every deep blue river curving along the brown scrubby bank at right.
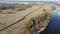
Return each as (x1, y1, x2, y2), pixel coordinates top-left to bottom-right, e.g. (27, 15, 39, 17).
(40, 6, 60, 34)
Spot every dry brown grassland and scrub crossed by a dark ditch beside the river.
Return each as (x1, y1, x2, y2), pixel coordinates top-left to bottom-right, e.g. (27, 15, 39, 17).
(0, 3, 60, 34)
